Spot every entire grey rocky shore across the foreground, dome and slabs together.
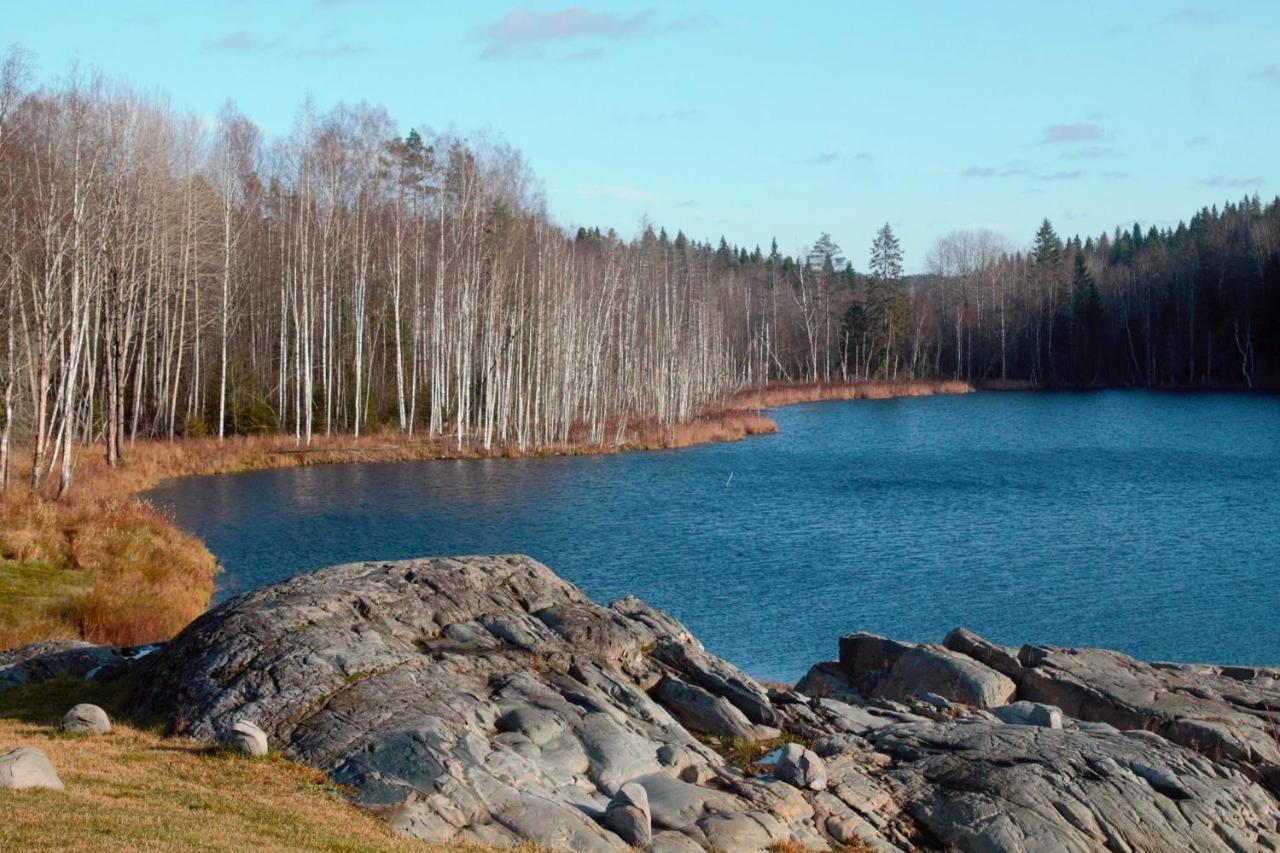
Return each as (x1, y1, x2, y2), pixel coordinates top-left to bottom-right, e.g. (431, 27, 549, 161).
(0, 556, 1280, 852)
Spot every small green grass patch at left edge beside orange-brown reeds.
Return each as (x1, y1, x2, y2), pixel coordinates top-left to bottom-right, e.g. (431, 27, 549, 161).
(0, 560, 93, 648)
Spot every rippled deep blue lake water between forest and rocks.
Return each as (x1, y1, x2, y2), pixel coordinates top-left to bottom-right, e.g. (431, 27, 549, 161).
(148, 391, 1280, 680)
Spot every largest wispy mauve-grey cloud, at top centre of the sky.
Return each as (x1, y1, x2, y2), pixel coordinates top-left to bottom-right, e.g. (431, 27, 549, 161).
(471, 6, 713, 60)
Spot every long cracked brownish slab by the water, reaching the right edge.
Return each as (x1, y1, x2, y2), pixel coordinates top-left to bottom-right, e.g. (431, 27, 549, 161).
(1019, 646, 1280, 778)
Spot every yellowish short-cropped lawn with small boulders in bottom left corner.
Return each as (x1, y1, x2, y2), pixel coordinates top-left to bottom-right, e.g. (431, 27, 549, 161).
(0, 679, 470, 852)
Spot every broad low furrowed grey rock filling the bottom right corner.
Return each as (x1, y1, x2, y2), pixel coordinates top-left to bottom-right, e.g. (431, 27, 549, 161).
(869, 722, 1276, 850)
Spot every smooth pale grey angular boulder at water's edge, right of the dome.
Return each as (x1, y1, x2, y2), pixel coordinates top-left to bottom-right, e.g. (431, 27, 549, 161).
(874, 646, 1018, 708)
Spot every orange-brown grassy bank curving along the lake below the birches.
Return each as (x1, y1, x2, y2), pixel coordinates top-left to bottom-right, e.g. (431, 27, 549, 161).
(0, 382, 972, 648)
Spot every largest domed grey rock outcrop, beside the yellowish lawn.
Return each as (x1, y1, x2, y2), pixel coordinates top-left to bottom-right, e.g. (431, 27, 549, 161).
(132, 556, 819, 849)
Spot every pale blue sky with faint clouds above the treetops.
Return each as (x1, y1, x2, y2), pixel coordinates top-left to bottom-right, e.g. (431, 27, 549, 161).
(0, 0, 1280, 272)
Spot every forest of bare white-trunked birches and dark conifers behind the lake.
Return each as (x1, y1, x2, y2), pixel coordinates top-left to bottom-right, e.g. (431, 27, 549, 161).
(0, 50, 1280, 493)
